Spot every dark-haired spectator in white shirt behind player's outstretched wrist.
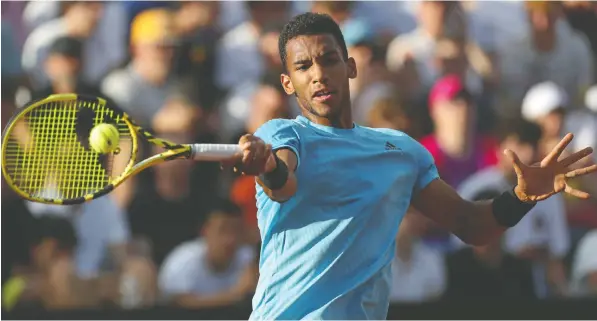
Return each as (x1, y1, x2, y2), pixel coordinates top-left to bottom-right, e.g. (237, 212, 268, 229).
(458, 120, 570, 298)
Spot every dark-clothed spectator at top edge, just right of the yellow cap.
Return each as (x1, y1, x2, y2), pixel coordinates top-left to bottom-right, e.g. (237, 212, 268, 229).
(174, 1, 220, 110)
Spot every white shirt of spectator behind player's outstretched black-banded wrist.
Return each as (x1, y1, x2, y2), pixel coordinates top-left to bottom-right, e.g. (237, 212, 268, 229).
(458, 167, 570, 258)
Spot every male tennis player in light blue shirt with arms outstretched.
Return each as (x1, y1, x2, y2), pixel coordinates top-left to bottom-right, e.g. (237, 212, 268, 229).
(227, 13, 597, 320)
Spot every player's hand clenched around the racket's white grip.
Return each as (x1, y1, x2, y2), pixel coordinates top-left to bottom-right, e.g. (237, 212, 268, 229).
(222, 134, 276, 175)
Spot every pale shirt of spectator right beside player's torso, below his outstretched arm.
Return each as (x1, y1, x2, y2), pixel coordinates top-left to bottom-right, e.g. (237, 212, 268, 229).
(390, 243, 447, 302)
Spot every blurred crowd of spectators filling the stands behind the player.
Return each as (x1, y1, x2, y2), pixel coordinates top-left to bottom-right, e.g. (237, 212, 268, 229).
(1, 1, 597, 309)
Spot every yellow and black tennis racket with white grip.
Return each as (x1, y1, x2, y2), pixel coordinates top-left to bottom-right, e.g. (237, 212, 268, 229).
(2, 94, 240, 205)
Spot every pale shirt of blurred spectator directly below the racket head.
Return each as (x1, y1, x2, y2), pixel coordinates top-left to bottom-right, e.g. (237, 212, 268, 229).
(26, 197, 130, 279)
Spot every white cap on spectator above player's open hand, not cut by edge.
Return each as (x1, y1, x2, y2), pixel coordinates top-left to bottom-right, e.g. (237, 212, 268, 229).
(522, 81, 568, 121)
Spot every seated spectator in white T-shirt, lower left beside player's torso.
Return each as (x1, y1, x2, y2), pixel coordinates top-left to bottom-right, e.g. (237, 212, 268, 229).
(159, 202, 258, 308)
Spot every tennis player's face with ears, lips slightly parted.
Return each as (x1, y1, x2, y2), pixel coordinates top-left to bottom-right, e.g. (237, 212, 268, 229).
(282, 34, 357, 120)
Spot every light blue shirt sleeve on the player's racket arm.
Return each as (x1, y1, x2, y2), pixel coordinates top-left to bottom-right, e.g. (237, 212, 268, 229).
(255, 119, 301, 167)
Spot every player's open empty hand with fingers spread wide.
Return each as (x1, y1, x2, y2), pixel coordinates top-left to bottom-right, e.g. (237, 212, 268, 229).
(504, 134, 597, 202)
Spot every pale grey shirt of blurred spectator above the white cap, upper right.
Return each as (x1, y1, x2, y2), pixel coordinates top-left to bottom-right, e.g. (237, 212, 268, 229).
(498, 20, 593, 113)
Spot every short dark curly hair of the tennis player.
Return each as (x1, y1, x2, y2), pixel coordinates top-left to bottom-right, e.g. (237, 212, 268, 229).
(278, 12, 348, 68)
